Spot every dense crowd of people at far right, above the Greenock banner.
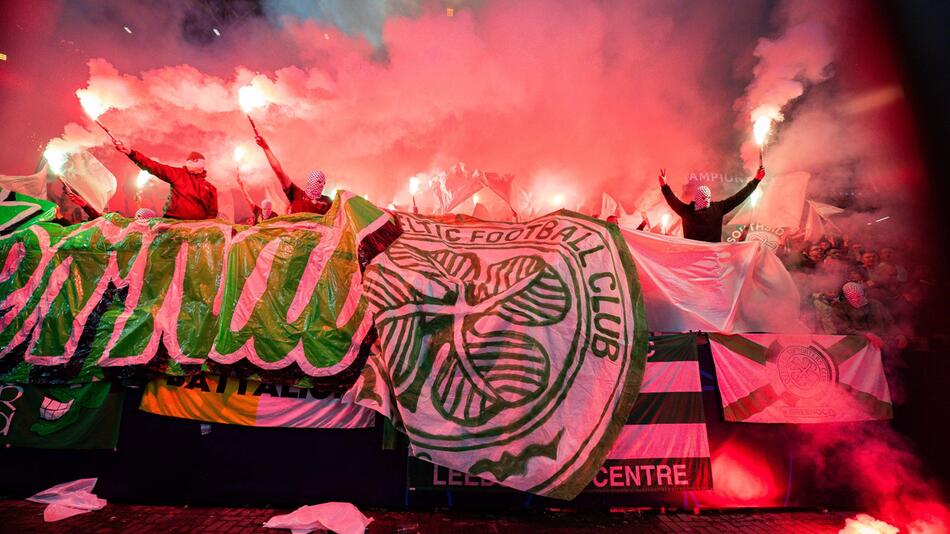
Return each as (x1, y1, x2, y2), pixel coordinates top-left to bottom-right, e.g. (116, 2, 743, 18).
(779, 236, 926, 349)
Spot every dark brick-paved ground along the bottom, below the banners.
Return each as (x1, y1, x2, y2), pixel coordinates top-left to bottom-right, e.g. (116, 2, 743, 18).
(0, 500, 854, 534)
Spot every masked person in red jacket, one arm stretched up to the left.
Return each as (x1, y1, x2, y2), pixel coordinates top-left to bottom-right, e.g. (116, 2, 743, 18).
(115, 141, 218, 221)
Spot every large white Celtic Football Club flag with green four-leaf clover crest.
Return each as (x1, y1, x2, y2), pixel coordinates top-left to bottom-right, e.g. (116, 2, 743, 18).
(350, 211, 647, 499)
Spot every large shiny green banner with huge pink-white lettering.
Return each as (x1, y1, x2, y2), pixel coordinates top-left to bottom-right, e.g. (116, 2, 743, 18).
(0, 192, 396, 387)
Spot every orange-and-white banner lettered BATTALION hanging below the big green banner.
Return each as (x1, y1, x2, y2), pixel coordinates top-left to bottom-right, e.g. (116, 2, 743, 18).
(139, 374, 376, 428)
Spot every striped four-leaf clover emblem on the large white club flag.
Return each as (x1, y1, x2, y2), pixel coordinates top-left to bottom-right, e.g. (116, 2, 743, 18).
(365, 242, 572, 426)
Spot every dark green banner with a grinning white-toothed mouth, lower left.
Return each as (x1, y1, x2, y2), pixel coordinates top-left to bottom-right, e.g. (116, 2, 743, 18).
(0, 382, 123, 449)
